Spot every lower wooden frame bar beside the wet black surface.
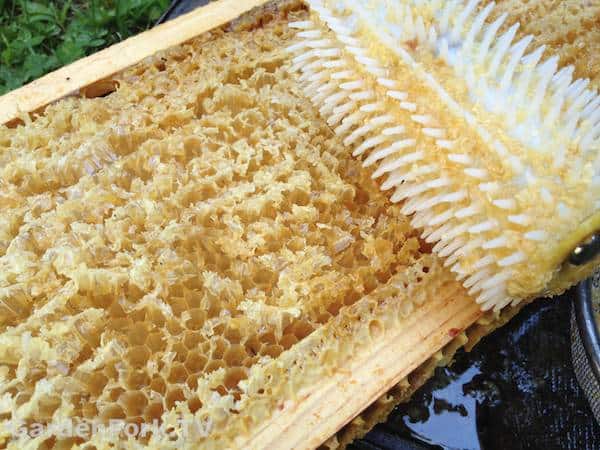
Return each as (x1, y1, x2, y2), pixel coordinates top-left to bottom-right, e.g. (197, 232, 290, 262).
(236, 292, 482, 450)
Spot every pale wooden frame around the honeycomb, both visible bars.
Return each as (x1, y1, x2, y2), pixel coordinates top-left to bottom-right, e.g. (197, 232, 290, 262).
(0, 0, 481, 449)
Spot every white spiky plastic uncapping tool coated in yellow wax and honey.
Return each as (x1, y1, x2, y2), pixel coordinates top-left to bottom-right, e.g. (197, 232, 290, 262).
(289, 0, 600, 310)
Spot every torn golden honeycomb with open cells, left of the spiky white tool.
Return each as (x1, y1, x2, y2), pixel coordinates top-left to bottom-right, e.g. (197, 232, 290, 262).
(0, 2, 451, 450)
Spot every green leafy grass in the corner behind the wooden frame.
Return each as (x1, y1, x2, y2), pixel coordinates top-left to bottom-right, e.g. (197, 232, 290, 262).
(0, 0, 169, 95)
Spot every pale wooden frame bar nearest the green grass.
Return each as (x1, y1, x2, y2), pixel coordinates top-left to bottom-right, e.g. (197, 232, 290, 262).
(0, 0, 268, 124)
